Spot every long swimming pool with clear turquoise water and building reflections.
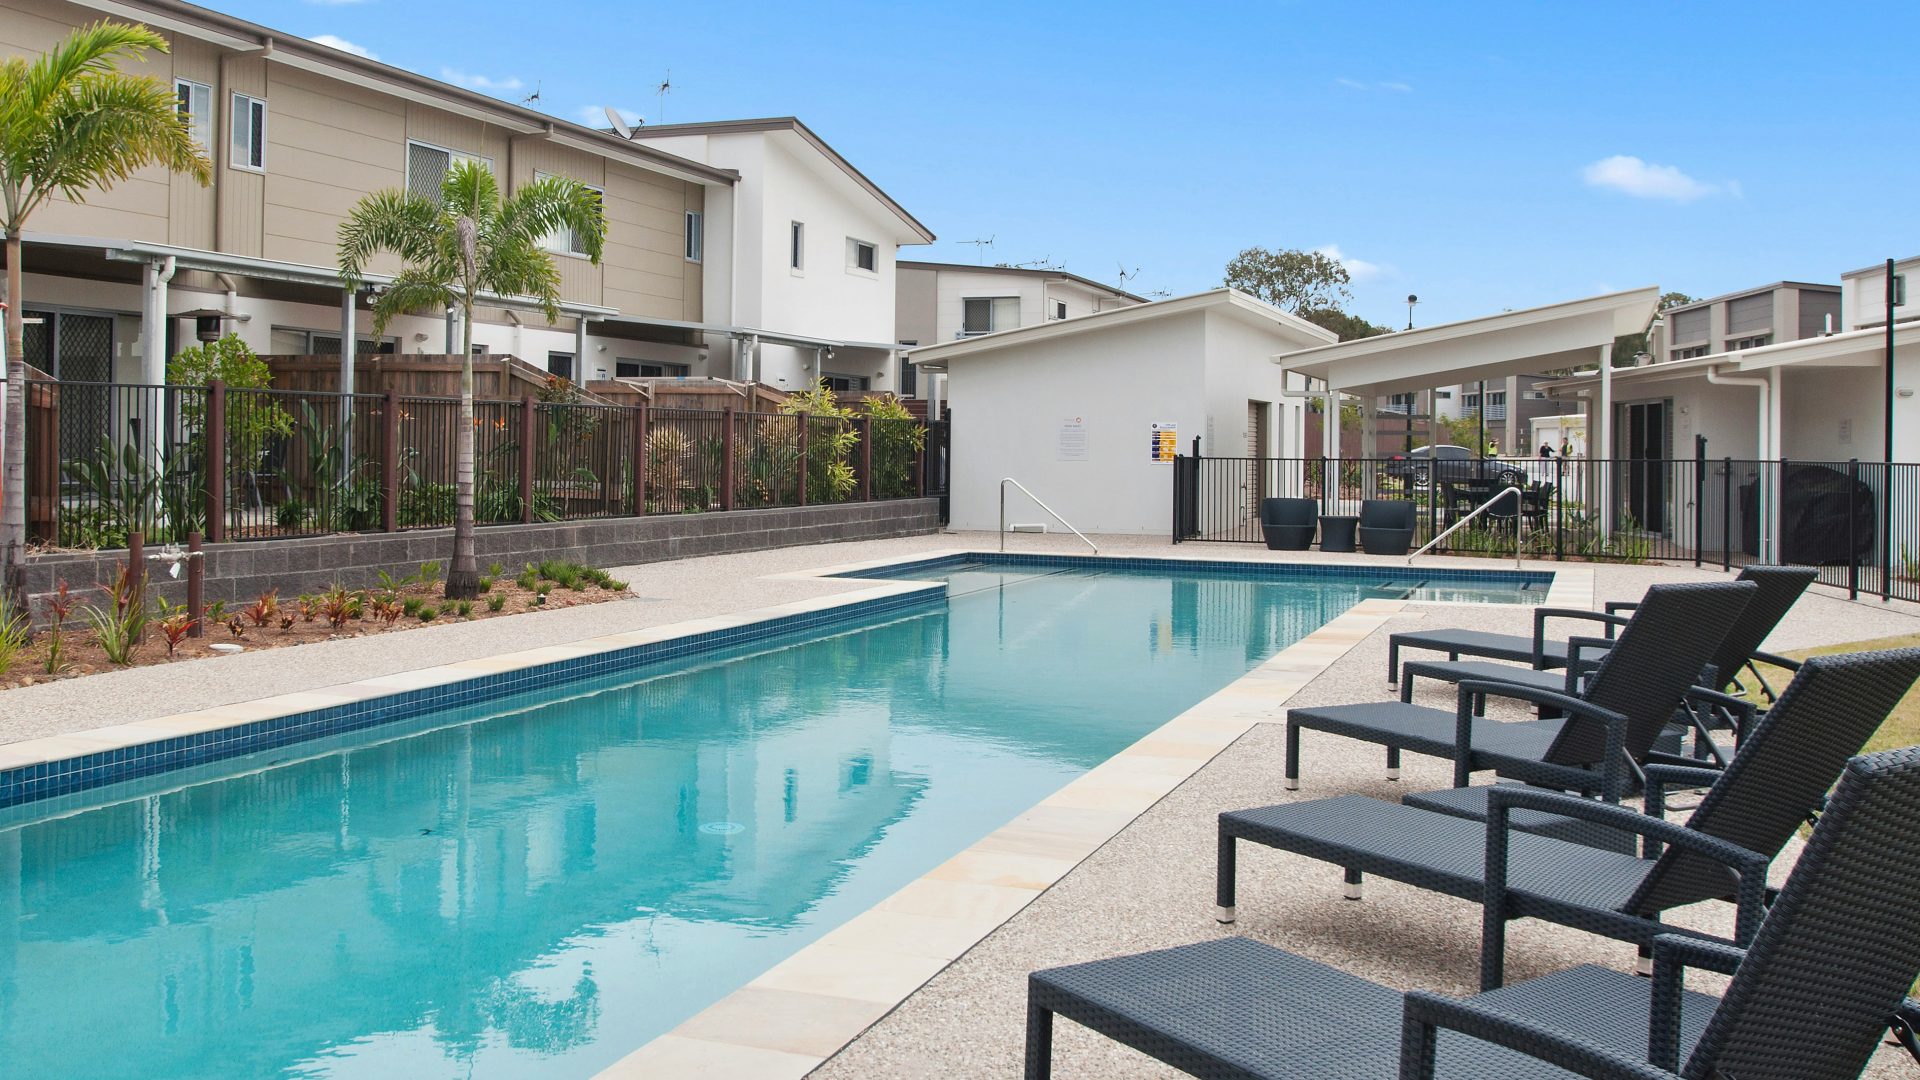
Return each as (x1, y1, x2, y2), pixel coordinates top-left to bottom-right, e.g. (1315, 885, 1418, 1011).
(0, 557, 1546, 1076)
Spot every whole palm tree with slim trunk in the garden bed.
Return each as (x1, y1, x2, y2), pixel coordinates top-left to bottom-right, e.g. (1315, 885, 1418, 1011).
(340, 161, 607, 600)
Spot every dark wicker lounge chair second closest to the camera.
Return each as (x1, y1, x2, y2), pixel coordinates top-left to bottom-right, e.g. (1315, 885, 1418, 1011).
(1217, 648, 1920, 986)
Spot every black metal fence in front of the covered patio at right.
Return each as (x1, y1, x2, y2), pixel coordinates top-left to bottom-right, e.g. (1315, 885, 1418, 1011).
(1173, 455, 1920, 600)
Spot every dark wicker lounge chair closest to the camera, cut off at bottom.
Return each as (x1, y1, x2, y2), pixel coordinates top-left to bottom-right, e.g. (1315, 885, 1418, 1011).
(1025, 748, 1920, 1080)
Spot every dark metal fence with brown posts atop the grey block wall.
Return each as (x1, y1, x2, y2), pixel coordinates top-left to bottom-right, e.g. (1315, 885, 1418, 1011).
(27, 380, 948, 548)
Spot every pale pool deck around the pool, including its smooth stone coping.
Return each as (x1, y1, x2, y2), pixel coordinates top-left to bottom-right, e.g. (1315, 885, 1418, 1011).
(0, 534, 1920, 1078)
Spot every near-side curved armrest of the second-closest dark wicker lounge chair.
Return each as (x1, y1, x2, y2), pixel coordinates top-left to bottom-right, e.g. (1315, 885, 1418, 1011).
(1484, 784, 1772, 944)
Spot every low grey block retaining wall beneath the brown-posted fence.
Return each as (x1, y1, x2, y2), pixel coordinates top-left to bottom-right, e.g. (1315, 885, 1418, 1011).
(27, 500, 939, 615)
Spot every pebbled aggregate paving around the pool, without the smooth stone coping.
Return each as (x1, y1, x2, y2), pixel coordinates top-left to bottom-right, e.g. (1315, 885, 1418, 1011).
(0, 534, 1920, 1080)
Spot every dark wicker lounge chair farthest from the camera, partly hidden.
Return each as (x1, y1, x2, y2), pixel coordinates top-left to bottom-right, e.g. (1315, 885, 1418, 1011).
(1386, 567, 1820, 690)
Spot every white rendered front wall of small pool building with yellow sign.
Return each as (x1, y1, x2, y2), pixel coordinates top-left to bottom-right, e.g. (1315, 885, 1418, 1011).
(947, 311, 1205, 534)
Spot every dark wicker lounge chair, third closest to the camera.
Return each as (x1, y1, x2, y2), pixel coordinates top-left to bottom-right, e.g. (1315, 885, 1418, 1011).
(1286, 582, 1759, 799)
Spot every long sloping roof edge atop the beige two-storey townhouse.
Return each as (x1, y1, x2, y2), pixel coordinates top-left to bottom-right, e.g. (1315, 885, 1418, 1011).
(73, 0, 739, 184)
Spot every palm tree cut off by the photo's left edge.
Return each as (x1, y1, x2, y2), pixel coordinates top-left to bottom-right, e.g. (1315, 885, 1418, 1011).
(0, 21, 213, 600)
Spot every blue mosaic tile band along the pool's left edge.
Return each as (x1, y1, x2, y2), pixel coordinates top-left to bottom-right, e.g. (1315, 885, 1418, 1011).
(0, 584, 947, 807)
